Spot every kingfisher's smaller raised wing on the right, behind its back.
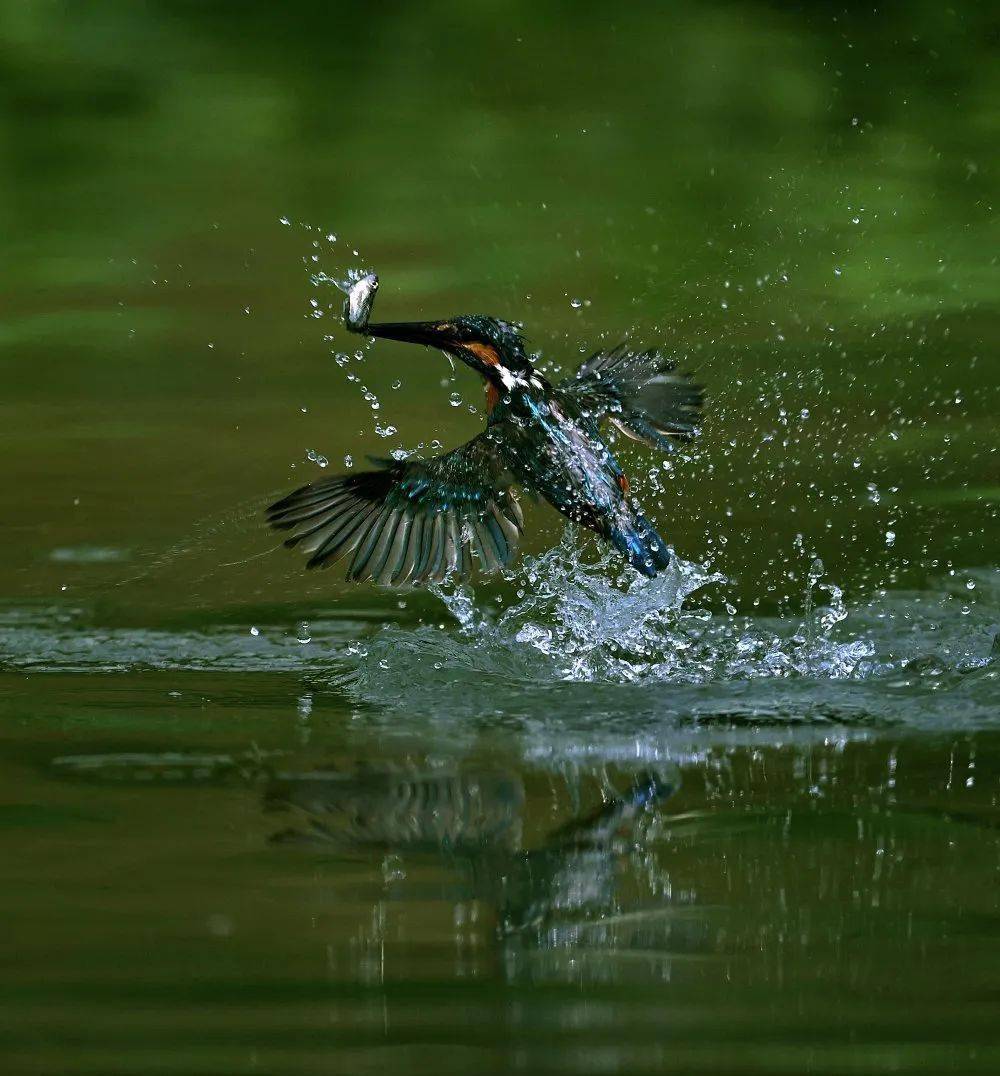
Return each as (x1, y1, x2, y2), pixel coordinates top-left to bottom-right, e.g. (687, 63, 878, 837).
(557, 344, 704, 452)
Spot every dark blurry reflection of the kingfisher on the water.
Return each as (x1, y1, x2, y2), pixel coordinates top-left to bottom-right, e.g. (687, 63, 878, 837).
(265, 770, 678, 943)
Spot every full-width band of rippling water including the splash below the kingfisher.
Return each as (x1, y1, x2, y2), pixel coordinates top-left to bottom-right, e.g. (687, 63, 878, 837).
(0, 534, 1000, 735)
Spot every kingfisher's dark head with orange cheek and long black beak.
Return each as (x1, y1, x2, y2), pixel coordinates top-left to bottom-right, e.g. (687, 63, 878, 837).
(361, 314, 534, 392)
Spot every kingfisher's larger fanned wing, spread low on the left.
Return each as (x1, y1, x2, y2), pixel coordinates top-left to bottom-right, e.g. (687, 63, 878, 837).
(267, 434, 524, 586)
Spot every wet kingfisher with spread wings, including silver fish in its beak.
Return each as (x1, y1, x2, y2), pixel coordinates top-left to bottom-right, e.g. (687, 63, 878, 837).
(267, 273, 703, 586)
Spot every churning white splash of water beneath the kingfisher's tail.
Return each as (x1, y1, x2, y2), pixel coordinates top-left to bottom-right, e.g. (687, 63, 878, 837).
(351, 528, 891, 710)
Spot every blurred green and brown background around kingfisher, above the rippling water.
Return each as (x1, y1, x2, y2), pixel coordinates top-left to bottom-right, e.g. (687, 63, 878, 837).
(0, 0, 1000, 615)
